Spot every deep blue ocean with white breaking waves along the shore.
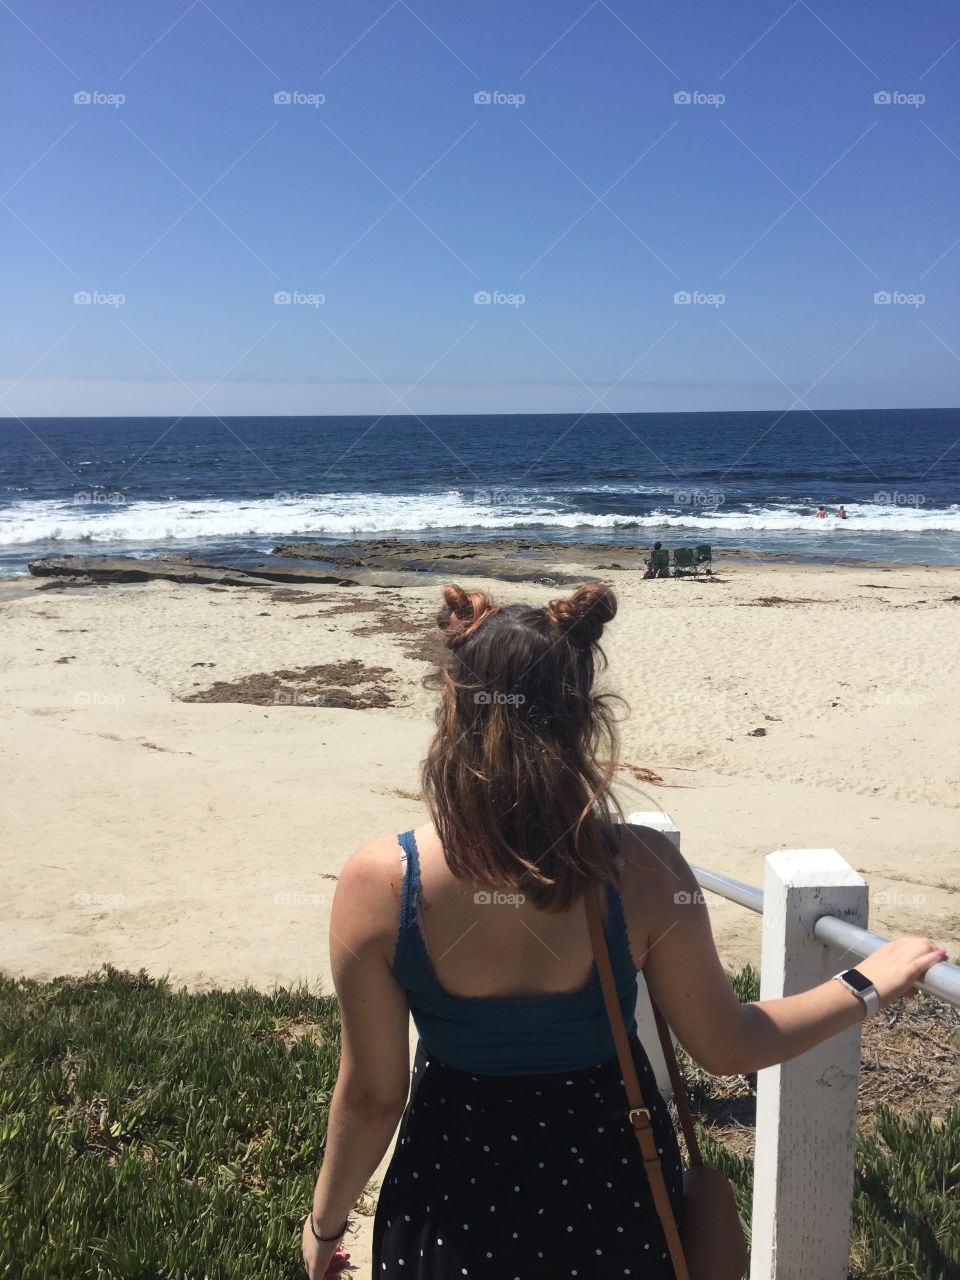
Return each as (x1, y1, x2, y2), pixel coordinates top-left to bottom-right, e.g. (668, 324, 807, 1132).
(0, 408, 960, 575)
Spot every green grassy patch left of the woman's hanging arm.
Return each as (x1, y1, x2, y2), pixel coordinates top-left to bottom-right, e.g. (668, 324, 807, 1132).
(0, 969, 339, 1280)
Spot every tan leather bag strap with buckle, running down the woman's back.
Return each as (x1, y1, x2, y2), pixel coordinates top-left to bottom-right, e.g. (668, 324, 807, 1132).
(584, 884, 690, 1280)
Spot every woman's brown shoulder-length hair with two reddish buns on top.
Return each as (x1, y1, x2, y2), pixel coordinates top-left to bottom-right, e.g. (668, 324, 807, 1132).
(422, 582, 622, 911)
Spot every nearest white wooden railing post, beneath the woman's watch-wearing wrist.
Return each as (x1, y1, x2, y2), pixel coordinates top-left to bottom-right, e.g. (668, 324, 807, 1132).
(750, 849, 868, 1280)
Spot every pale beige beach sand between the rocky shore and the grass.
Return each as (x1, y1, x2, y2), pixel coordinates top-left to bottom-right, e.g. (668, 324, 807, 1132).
(0, 552, 960, 1261)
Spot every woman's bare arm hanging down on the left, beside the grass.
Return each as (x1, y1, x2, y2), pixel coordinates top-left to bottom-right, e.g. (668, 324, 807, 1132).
(303, 837, 410, 1280)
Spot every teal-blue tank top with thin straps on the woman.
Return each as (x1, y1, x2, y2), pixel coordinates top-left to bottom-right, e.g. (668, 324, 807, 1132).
(393, 831, 636, 1075)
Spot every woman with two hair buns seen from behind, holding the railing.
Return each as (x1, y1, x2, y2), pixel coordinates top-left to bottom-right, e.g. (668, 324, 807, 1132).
(303, 585, 943, 1280)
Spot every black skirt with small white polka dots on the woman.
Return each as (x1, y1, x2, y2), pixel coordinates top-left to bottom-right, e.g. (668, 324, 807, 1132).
(372, 1041, 682, 1280)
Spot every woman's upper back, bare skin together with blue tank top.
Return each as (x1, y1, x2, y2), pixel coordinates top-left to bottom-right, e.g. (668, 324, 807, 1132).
(392, 828, 647, 1075)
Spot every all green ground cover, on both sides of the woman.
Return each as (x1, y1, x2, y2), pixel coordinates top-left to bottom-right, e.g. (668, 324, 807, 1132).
(0, 968, 960, 1280)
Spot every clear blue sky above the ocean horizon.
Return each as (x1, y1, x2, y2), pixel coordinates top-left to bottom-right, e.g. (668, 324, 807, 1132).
(0, 0, 960, 416)
